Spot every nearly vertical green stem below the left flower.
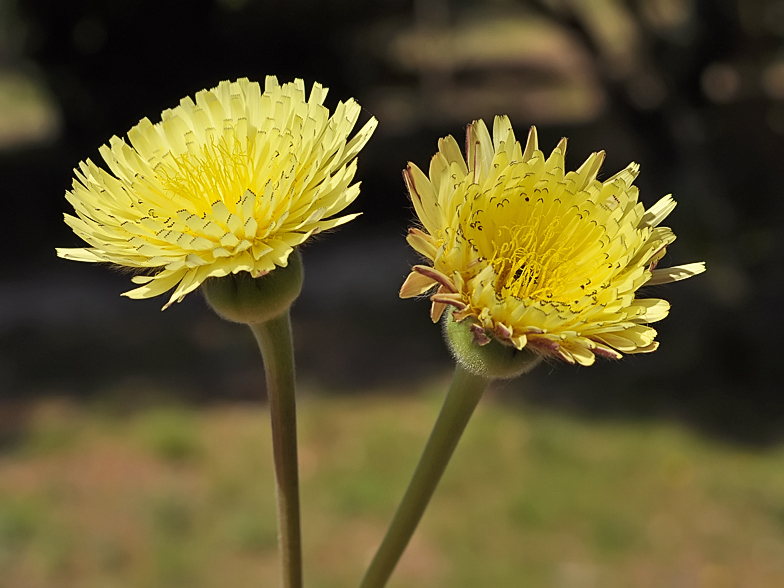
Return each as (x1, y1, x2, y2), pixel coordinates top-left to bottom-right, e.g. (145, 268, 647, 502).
(249, 309, 302, 588)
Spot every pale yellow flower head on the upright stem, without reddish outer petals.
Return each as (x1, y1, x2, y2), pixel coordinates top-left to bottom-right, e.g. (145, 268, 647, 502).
(57, 76, 376, 309)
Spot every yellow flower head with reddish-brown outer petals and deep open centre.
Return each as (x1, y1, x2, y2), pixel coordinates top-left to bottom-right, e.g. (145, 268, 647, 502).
(400, 116, 705, 365)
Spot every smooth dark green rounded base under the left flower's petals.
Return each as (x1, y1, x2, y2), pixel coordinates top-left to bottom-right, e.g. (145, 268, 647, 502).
(201, 249, 304, 324)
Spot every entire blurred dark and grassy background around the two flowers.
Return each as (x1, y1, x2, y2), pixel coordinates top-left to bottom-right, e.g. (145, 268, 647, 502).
(0, 0, 784, 588)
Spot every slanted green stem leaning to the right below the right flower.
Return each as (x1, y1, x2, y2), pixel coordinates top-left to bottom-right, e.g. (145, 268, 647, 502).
(360, 364, 490, 588)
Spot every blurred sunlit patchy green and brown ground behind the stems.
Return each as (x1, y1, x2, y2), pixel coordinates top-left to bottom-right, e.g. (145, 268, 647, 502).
(0, 381, 784, 588)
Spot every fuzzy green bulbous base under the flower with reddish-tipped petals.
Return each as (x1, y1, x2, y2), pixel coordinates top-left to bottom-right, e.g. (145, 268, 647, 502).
(443, 312, 542, 380)
